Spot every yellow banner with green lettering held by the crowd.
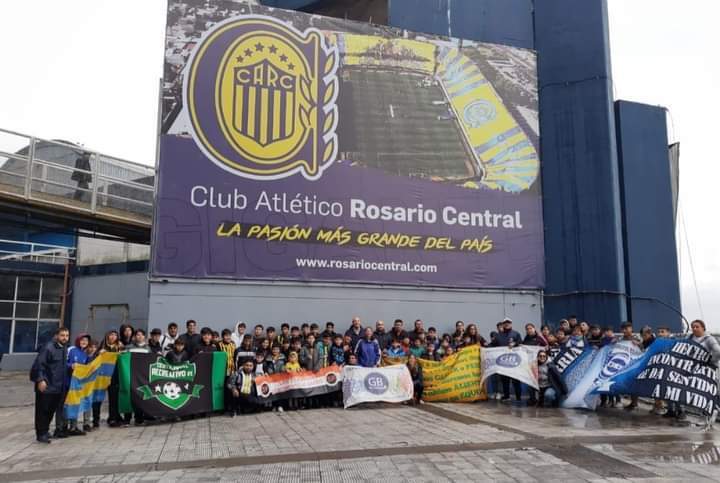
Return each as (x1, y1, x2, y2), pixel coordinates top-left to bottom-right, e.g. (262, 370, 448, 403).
(418, 345, 487, 402)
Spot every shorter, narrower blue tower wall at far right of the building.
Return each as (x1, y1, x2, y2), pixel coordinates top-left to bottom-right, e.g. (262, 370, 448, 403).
(615, 101, 682, 331)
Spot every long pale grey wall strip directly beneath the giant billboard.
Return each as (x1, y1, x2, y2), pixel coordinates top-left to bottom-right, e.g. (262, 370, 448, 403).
(149, 281, 541, 337)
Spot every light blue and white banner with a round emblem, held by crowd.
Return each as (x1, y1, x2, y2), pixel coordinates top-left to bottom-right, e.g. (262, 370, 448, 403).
(562, 341, 642, 410)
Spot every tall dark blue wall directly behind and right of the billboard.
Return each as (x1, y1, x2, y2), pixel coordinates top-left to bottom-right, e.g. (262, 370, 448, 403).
(389, 0, 627, 325)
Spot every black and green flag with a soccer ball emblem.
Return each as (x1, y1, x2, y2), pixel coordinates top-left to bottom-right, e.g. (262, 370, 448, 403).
(117, 352, 227, 418)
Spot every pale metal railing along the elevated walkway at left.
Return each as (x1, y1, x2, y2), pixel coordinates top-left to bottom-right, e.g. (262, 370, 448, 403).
(0, 128, 155, 226)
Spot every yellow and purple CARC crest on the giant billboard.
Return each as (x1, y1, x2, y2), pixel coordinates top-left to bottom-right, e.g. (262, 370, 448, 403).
(184, 15, 338, 179)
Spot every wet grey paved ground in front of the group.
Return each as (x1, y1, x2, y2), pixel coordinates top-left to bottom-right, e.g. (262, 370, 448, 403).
(0, 373, 720, 482)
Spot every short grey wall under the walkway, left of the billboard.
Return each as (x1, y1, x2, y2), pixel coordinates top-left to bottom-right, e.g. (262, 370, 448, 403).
(70, 272, 148, 339)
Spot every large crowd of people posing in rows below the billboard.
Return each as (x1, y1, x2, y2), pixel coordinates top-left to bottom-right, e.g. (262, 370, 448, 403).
(31, 316, 720, 442)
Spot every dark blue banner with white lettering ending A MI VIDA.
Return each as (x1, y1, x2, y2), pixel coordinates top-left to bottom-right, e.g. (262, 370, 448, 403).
(597, 336, 720, 415)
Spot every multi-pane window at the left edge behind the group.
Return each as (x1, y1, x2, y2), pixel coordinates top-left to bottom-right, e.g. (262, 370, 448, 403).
(0, 275, 64, 354)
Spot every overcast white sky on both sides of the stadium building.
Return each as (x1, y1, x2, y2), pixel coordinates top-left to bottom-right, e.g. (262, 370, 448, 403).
(0, 0, 720, 331)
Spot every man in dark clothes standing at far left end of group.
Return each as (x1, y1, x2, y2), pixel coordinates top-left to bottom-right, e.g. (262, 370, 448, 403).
(30, 327, 70, 443)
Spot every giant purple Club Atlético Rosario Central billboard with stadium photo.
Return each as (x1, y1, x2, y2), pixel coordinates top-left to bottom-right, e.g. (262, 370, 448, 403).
(152, 0, 544, 288)
